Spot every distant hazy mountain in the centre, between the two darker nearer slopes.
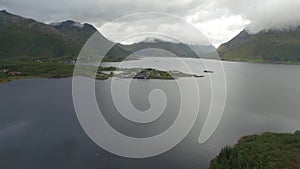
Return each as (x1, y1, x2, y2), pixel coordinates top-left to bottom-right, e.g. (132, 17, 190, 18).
(121, 38, 216, 58)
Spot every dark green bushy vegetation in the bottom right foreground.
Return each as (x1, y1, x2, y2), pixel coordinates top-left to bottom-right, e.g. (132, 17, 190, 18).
(209, 131, 300, 169)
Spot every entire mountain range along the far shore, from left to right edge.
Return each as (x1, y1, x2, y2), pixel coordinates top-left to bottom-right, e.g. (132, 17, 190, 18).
(0, 10, 300, 63)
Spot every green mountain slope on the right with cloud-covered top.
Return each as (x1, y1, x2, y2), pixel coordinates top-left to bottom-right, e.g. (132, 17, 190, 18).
(217, 27, 300, 63)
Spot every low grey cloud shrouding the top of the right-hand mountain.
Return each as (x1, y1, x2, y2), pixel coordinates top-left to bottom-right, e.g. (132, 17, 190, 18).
(215, 0, 300, 33)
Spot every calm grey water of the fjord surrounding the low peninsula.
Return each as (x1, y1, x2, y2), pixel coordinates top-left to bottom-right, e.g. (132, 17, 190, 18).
(0, 58, 300, 169)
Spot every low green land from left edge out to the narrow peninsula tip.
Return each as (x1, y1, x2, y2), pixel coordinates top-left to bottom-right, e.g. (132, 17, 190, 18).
(0, 57, 203, 83)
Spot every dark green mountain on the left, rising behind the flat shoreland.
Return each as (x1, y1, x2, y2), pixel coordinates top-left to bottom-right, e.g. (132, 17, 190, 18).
(0, 10, 127, 58)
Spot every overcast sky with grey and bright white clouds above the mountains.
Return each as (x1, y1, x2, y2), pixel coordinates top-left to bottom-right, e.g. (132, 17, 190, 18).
(0, 0, 300, 46)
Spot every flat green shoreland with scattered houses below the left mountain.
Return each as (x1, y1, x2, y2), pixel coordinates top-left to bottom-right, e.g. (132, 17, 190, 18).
(0, 57, 116, 83)
